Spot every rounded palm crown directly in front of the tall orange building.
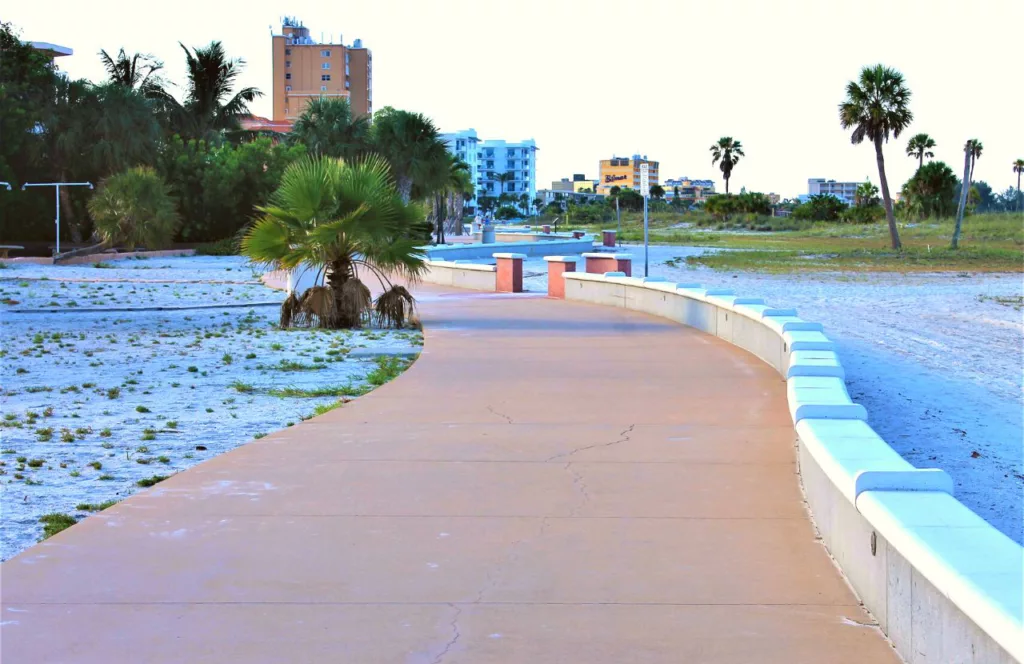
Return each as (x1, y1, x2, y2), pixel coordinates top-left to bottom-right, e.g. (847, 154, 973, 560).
(290, 96, 370, 161)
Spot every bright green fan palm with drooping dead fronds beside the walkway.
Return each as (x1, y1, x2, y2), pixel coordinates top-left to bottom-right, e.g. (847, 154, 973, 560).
(242, 156, 425, 328)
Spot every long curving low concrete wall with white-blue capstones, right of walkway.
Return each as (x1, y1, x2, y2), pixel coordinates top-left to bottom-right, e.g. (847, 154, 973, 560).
(561, 272, 1024, 664)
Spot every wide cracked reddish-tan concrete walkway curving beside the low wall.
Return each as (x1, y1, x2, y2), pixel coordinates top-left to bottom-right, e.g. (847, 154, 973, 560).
(0, 288, 897, 664)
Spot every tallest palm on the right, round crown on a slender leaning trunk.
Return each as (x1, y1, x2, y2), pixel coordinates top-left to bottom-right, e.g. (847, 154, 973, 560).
(839, 65, 913, 250)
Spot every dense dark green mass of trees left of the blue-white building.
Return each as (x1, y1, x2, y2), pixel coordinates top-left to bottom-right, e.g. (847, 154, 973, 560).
(0, 24, 472, 249)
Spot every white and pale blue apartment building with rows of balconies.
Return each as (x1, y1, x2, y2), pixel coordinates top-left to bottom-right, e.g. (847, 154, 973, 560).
(441, 129, 537, 208)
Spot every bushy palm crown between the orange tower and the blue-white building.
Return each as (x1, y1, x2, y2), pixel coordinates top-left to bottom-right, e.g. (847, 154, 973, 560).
(371, 107, 447, 203)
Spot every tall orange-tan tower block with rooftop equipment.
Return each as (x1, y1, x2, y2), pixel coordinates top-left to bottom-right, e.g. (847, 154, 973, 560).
(271, 17, 374, 122)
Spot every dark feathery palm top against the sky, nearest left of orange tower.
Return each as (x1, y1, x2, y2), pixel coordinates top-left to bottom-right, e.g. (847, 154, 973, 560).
(161, 41, 263, 138)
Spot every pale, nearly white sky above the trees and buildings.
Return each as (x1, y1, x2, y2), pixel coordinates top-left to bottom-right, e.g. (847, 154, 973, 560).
(9, 0, 1024, 197)
